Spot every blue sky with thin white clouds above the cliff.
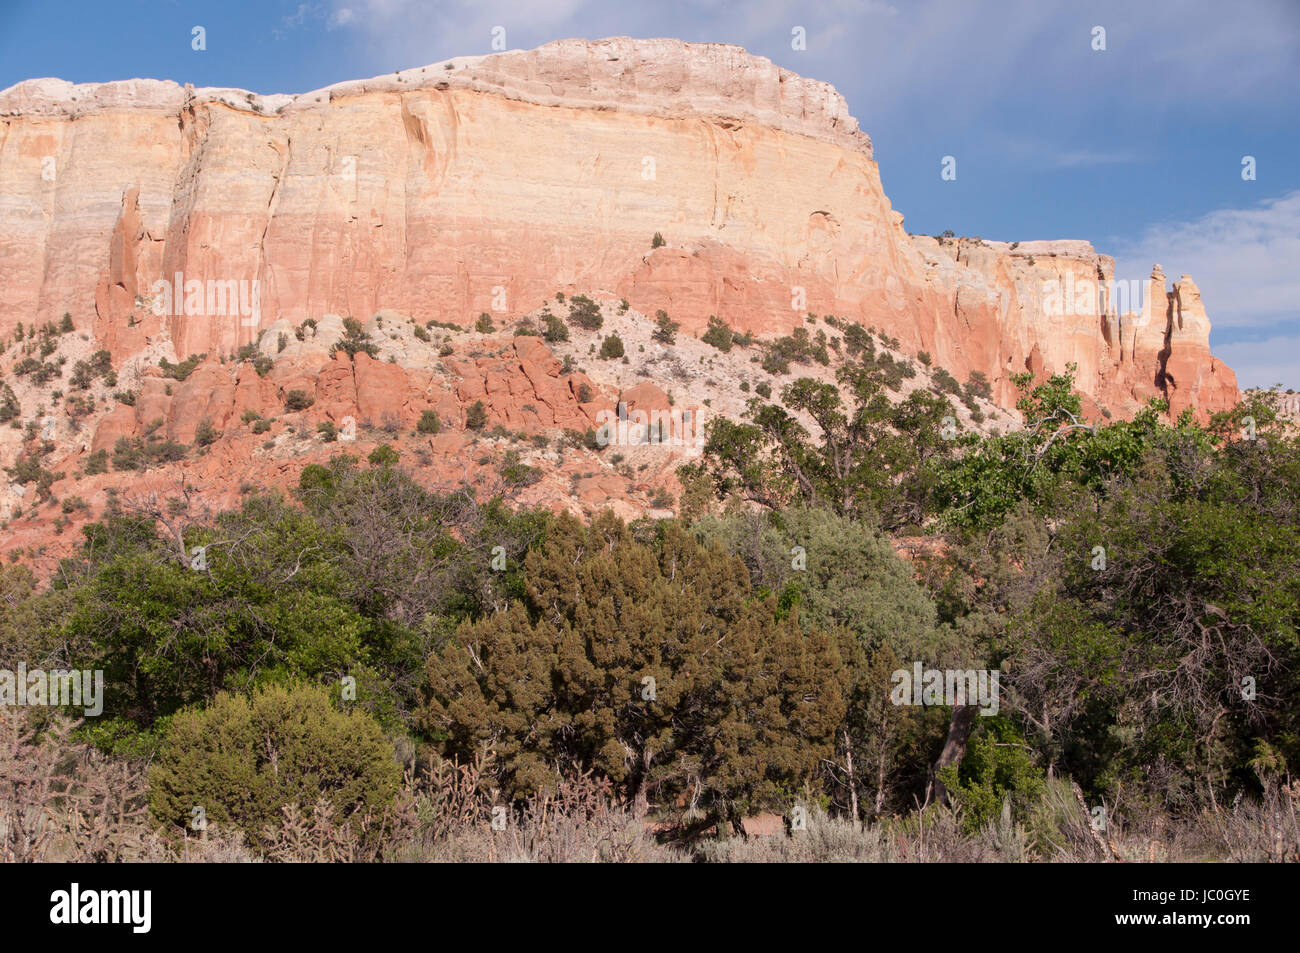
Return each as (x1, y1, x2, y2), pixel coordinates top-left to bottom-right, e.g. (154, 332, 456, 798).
(0, 0, 1300, 389)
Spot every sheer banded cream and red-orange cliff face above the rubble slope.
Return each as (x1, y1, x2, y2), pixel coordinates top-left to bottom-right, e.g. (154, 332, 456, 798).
(0, 38, 1238, 416)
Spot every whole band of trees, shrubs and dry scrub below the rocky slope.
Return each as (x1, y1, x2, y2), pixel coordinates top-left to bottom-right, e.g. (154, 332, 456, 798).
(0, 358, 1300, 862)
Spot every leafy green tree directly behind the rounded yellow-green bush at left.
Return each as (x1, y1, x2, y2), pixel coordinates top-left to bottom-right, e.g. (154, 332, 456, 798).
(61, 498, 377, 727)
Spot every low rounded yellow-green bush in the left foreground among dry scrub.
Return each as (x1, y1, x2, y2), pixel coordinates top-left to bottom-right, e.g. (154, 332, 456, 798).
(150, 685, 400, 844)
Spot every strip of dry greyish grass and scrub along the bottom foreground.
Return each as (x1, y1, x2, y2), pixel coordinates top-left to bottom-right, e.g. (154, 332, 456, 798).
(0, 709, 1300, 863)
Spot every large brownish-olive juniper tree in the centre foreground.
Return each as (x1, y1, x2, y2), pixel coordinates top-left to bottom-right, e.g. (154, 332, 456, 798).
(424, 515, 850, 822)
